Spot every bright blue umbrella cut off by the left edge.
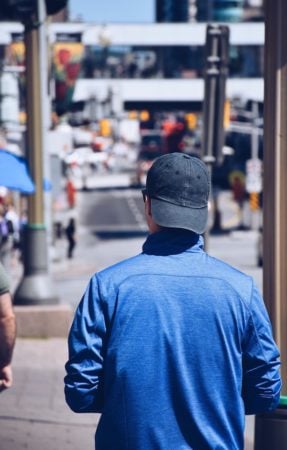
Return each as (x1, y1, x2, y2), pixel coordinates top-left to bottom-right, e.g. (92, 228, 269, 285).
(0, 149, 35, 194)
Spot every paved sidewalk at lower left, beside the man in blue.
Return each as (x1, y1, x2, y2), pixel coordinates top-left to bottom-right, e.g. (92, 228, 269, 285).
(0, 339, 98, 450)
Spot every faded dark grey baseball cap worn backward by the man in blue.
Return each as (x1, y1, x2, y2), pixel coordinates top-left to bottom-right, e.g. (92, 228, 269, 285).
(146, 153, 210, 234)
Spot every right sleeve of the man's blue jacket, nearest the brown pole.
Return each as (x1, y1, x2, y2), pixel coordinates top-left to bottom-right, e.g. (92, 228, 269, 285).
(242, 285, 281, 414)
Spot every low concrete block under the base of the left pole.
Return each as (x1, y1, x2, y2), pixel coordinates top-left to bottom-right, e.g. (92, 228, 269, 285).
(14, 305, 73, 338)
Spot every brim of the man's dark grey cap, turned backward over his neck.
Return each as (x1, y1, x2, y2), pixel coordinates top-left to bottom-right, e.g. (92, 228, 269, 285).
(151, 198, 208, 234)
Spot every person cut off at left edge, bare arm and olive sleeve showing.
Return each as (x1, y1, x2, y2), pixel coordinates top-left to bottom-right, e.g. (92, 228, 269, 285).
(0, 263, 16, 392)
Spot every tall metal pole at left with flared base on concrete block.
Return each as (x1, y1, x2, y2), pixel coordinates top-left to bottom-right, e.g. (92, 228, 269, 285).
(14, 0, 58, 305)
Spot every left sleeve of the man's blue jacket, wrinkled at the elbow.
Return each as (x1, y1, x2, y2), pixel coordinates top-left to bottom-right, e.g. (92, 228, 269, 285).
(64, 275, 106, 412)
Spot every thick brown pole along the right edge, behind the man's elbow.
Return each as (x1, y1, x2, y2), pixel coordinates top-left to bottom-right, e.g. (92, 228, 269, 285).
(255, 0, 287, 450)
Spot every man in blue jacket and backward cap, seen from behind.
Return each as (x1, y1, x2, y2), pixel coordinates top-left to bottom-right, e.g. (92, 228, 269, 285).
(64, 153, 281, 450)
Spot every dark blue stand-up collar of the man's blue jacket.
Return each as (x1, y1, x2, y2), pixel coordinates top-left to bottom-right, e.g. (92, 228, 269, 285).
(143, 229, 204, 256)
